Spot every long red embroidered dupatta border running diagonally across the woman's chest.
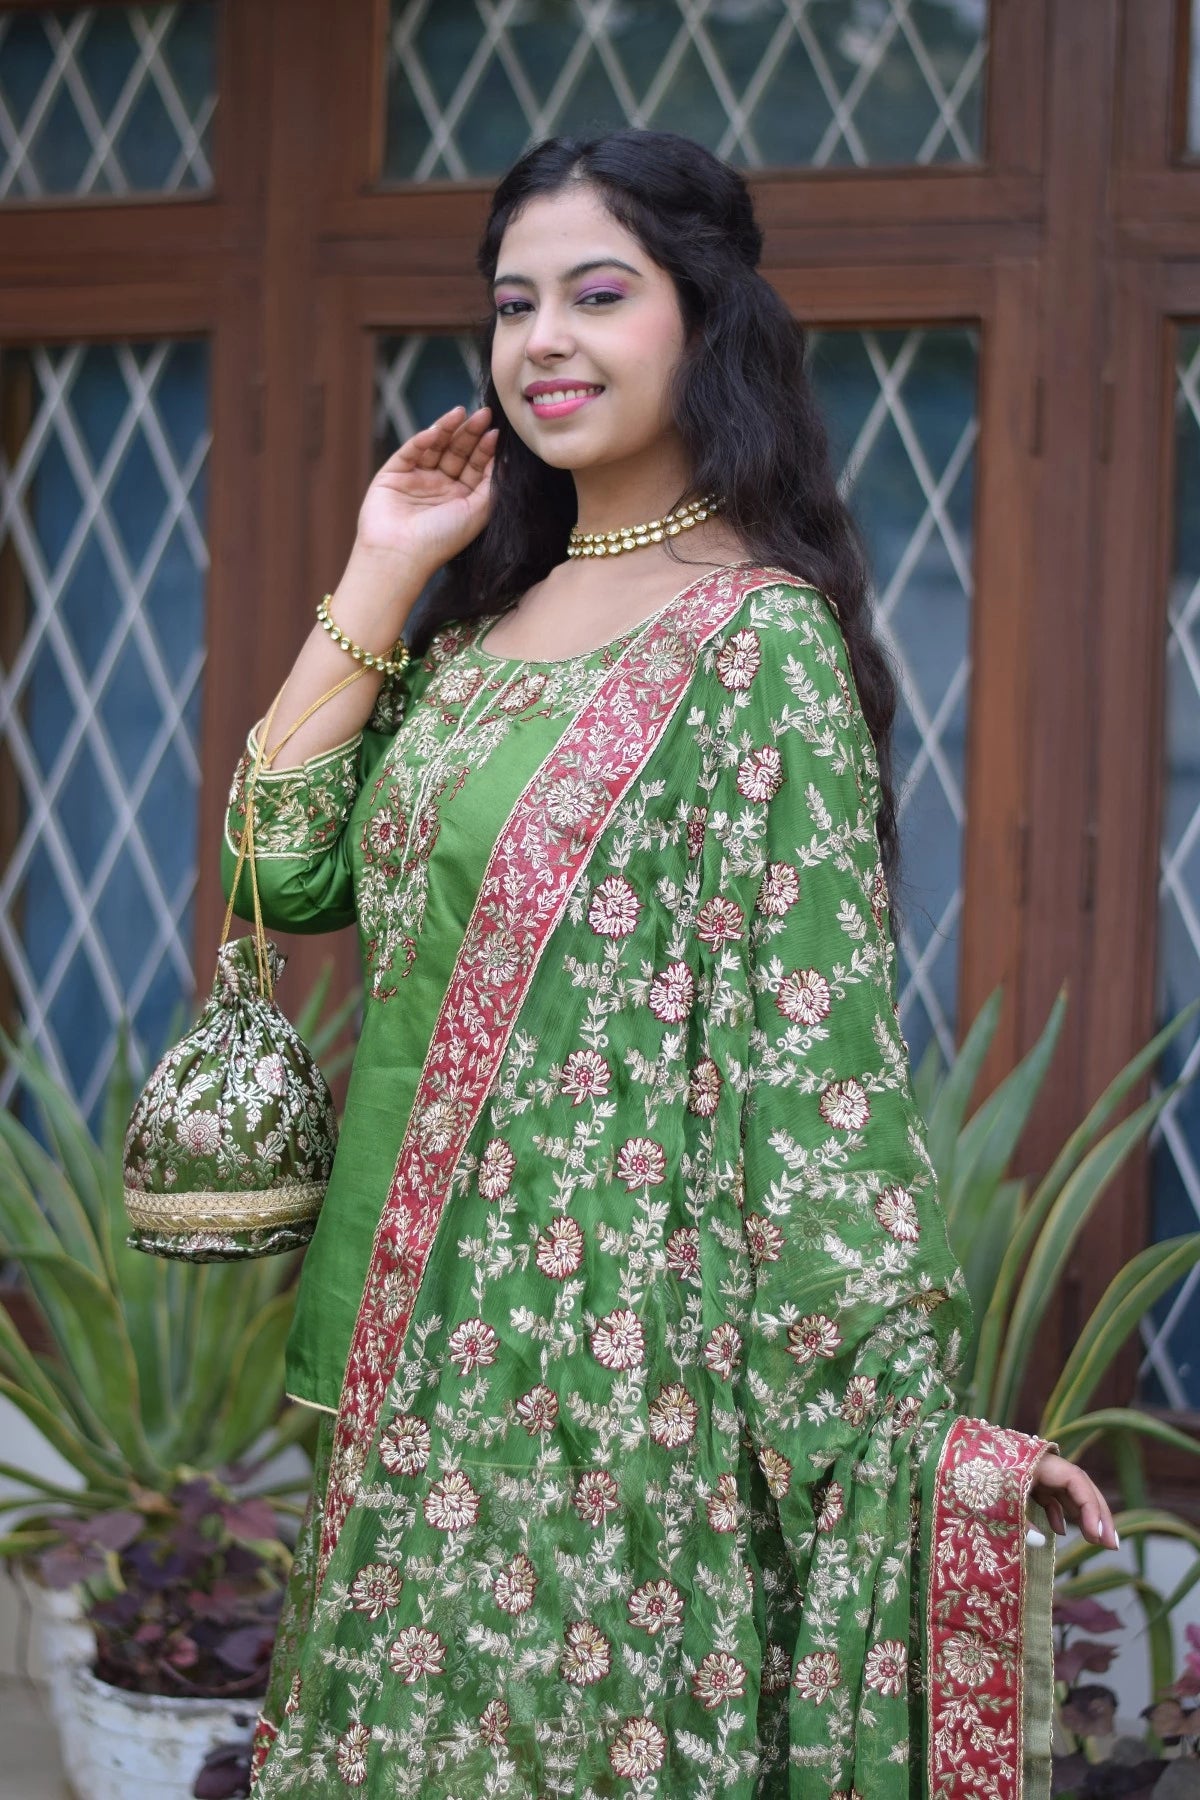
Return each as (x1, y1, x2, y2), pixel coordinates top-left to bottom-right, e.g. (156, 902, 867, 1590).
(317, 567, 795, 1584)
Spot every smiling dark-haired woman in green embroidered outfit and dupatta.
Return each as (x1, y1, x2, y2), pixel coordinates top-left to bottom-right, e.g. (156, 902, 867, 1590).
(223, 131, 1115, 1800)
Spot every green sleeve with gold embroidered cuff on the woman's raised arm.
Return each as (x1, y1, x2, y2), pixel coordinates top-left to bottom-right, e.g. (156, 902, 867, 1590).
(221, 662, 423, 932)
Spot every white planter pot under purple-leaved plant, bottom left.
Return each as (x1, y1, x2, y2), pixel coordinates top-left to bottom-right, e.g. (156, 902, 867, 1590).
(56, 1663, 257, 1800)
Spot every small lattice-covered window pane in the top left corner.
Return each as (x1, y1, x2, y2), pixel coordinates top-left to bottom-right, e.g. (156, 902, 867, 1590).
(0, 0, 216, 202)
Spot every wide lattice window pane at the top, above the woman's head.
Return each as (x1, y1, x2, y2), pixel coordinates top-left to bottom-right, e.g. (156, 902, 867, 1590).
(383, 0, 988, 182)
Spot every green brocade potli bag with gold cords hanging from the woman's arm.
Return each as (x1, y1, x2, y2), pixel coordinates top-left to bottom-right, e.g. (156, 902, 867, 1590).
(124, 670, 363, 1262)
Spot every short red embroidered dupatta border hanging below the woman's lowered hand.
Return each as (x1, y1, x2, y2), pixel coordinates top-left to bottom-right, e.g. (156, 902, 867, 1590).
(925, 1418, 1054, 1800)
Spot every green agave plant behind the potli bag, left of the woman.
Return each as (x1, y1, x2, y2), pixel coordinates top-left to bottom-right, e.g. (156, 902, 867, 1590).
(0, 965, 358, 1557)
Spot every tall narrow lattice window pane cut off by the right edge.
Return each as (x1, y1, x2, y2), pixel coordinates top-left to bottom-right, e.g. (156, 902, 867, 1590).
(1141, 324, 1200, 1409)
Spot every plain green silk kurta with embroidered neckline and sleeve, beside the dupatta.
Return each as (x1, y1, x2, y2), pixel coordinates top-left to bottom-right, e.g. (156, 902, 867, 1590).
(221, 619, 658, 1411)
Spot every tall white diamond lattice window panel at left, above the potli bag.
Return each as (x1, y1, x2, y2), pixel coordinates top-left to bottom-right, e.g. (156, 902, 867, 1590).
(0, 340, 209, 1114)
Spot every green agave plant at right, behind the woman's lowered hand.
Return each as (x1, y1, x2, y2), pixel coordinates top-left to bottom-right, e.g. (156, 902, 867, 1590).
(914, 988, 1200, 1694)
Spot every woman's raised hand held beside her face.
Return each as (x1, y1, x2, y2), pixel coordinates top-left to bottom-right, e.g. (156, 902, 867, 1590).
(358, 407, 497, 574)
